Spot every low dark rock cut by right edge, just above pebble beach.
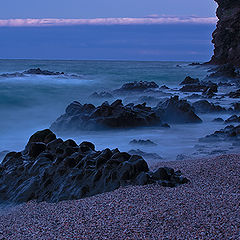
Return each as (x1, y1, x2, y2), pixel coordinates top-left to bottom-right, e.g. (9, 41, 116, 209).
(199, 125, 240, 142)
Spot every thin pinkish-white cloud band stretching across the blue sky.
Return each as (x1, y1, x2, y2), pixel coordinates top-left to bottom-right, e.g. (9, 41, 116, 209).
(0, 17, 217, 27)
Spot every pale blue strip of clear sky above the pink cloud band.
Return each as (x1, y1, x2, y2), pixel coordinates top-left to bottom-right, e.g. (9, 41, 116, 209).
(0, 0, 216, 19)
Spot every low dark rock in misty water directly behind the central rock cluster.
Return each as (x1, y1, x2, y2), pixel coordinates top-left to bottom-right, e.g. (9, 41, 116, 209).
(114, 81, 159, 92)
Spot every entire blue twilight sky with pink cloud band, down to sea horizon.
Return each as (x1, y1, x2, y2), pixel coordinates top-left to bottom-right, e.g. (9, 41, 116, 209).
(0, 0, 217, 61)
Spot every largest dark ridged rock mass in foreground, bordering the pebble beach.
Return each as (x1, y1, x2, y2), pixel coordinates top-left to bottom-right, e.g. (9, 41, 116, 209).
(0, 129, 188, 203)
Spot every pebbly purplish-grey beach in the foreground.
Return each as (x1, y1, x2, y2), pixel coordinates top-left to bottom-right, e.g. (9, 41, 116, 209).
(0, 155, 240, 240)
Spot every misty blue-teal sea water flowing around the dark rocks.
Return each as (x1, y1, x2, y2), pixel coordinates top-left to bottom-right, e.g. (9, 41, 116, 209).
(0, 60, 236, 164)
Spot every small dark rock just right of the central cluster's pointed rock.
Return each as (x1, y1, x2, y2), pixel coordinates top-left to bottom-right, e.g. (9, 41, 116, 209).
(192, 100, 226, 113)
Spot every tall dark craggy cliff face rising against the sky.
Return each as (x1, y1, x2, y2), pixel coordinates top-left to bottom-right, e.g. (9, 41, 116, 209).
(209, 0, 240, 67)
